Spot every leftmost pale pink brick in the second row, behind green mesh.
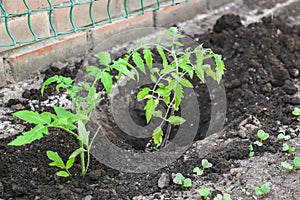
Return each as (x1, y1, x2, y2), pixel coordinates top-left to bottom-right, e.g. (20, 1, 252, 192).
(0, 12, 50, 46)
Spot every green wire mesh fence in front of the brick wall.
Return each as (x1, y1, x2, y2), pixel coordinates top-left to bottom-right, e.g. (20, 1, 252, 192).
(0, 0, 188, 47)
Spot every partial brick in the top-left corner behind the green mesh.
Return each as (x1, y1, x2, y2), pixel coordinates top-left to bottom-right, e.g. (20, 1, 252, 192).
(2, 0, 67, 12)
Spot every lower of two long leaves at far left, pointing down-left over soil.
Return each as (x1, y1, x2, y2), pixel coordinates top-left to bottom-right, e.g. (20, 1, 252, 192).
(8, 124, 48, 146)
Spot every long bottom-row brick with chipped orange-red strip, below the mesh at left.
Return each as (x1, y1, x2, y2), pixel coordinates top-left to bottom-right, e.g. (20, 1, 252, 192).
(7, 32, 89, 82)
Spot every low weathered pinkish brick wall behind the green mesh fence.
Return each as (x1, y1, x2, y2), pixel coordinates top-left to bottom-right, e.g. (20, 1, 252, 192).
(0, 0, 242, 87)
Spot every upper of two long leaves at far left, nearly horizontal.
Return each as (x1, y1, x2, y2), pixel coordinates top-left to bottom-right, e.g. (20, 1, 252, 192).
(13, 110, 51, 125)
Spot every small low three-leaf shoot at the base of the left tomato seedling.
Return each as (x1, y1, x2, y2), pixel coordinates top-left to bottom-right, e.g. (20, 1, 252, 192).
(47, 151, 75, 177)
